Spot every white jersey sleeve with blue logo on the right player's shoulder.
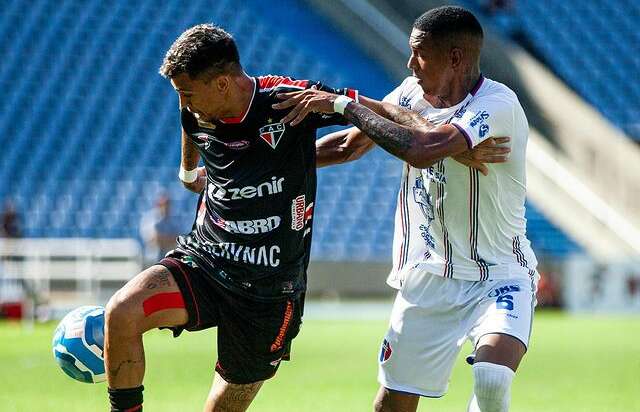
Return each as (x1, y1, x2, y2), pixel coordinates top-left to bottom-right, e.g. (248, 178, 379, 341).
(451, 95, 515, 148)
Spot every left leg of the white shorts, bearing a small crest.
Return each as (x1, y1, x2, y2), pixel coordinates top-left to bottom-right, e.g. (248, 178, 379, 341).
(378, 290, 466, 397)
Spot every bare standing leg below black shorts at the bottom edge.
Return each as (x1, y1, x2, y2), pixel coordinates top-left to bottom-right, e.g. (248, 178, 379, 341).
(204, 373, 264, 412)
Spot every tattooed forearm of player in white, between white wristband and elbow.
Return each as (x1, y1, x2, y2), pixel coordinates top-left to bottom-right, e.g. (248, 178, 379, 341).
(344, 102, 413, 160)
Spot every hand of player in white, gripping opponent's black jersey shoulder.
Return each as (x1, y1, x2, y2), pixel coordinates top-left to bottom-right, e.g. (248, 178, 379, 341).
(272, 88, 338, 126)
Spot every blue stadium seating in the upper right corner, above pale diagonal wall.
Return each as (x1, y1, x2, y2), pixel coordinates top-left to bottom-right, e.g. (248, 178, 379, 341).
(461, 0, 640, 141)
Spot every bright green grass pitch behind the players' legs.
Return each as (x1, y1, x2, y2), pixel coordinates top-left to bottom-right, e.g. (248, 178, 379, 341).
(0, 312, 640, 412)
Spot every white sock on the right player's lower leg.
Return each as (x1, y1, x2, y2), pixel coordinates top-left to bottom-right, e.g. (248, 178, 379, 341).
(467, 362, 515, 412)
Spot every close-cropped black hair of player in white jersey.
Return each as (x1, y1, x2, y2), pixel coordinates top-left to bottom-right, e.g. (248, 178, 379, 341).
(413, 6, 484, 41)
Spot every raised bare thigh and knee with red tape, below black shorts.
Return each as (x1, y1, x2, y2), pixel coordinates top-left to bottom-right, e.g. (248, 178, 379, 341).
(106, 265, 188, 332)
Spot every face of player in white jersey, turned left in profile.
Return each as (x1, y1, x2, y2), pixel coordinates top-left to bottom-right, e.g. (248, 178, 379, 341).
(407, 28, 453, 96)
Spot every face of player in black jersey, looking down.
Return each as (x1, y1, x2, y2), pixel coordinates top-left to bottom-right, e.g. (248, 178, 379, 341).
(171, 73, 228, 121)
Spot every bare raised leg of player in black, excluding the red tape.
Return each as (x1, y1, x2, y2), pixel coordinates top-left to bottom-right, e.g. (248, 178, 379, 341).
(104, 265, 187, 389)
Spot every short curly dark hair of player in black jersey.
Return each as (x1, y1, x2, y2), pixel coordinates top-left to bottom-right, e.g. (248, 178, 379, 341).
(160, 24, 242, 79)
